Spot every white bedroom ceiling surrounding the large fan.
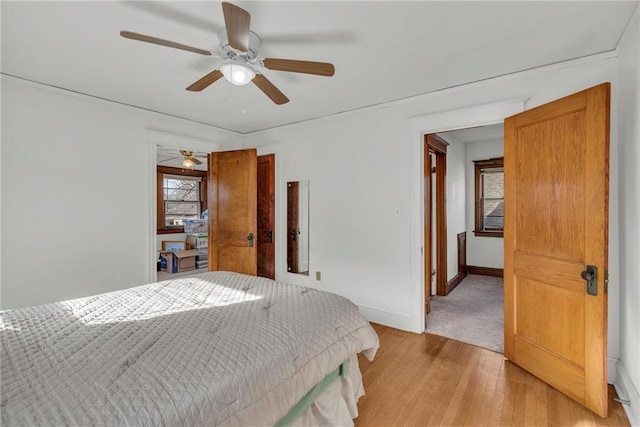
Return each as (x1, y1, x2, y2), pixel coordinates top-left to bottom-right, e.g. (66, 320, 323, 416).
(1, 1, 637, 133)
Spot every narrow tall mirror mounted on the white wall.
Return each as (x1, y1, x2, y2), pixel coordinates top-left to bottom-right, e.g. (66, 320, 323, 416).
(287, 181, 309, 276)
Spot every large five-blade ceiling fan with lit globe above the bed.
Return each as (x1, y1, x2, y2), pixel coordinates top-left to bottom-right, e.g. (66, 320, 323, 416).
(120, 2, 335, 105)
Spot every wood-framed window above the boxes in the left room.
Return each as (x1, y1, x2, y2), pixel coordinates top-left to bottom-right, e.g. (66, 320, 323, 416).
(156, 166, 207, 234)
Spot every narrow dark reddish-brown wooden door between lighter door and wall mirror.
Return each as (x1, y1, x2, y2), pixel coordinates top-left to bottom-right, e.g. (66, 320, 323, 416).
(257, 154, 276, 279)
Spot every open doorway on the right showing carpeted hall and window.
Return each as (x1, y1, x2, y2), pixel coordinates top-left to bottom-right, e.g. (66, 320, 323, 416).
(425, 124, 504, 352)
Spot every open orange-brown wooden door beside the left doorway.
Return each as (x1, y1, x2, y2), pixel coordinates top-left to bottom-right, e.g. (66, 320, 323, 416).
(209, 149, 257, 275)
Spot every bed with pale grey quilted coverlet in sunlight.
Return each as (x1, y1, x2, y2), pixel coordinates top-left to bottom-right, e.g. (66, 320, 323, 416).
(0, 272, 378, 426)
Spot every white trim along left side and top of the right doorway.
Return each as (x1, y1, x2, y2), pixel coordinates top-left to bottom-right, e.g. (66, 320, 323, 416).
(409, 99, 526, 333)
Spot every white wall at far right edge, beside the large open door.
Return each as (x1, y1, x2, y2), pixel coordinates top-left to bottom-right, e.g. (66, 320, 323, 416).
(609, 9, 640, 425)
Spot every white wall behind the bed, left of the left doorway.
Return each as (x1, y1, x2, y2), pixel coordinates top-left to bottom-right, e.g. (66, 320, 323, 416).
(1, 77, 237, 308)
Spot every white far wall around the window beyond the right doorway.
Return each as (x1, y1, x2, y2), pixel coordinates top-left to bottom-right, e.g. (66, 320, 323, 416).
(465, 139, 504, 268)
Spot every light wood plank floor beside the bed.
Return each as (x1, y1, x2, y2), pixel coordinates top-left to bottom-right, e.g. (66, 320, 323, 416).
(355, 325, 630, 427)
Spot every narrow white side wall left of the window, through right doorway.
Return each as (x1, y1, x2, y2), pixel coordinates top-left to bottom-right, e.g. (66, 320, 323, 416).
(446, 140, 469, 281)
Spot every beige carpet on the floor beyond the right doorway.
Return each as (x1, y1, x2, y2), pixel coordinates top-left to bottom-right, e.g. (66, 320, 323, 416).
(427, 274, 504, 353)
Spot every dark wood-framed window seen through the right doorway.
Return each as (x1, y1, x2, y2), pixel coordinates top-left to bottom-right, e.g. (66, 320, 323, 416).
(473, 157, 504, 237)
